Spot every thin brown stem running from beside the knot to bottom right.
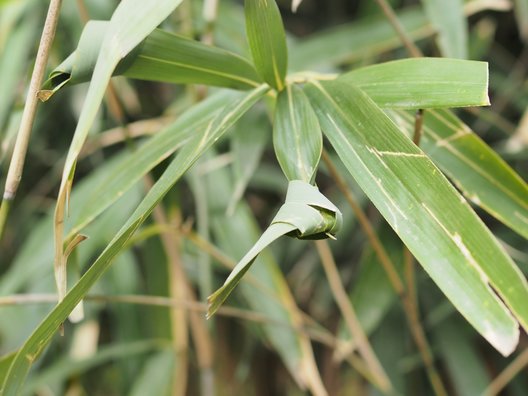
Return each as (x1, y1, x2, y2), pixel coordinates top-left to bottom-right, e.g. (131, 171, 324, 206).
(322, 150, 447, 396)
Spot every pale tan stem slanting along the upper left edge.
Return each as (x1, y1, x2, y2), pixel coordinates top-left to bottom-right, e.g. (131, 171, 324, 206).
(0, 0, 62, 237)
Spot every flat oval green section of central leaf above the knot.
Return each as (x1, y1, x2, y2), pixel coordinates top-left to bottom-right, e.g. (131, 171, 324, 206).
(273, 85, 323, 183)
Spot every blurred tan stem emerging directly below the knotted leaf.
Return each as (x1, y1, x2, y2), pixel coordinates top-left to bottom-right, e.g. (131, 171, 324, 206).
(315, 240, 392, 393)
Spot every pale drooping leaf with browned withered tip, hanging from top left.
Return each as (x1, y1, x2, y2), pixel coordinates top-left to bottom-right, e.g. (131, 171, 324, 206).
(54, 0, 181, 301)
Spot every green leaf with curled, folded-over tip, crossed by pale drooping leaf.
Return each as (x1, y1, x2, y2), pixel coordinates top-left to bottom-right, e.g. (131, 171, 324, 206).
(43, 21, 261, 95)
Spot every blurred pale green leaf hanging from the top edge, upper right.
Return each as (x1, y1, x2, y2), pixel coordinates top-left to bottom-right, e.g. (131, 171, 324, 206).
(422, 0, 468, 59)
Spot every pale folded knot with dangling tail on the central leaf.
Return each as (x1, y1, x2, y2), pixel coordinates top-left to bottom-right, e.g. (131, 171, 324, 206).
(207, 180, 342, 317)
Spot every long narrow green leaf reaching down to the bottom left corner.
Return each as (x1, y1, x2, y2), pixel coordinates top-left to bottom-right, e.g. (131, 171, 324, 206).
(0, 86, 269, 396)
